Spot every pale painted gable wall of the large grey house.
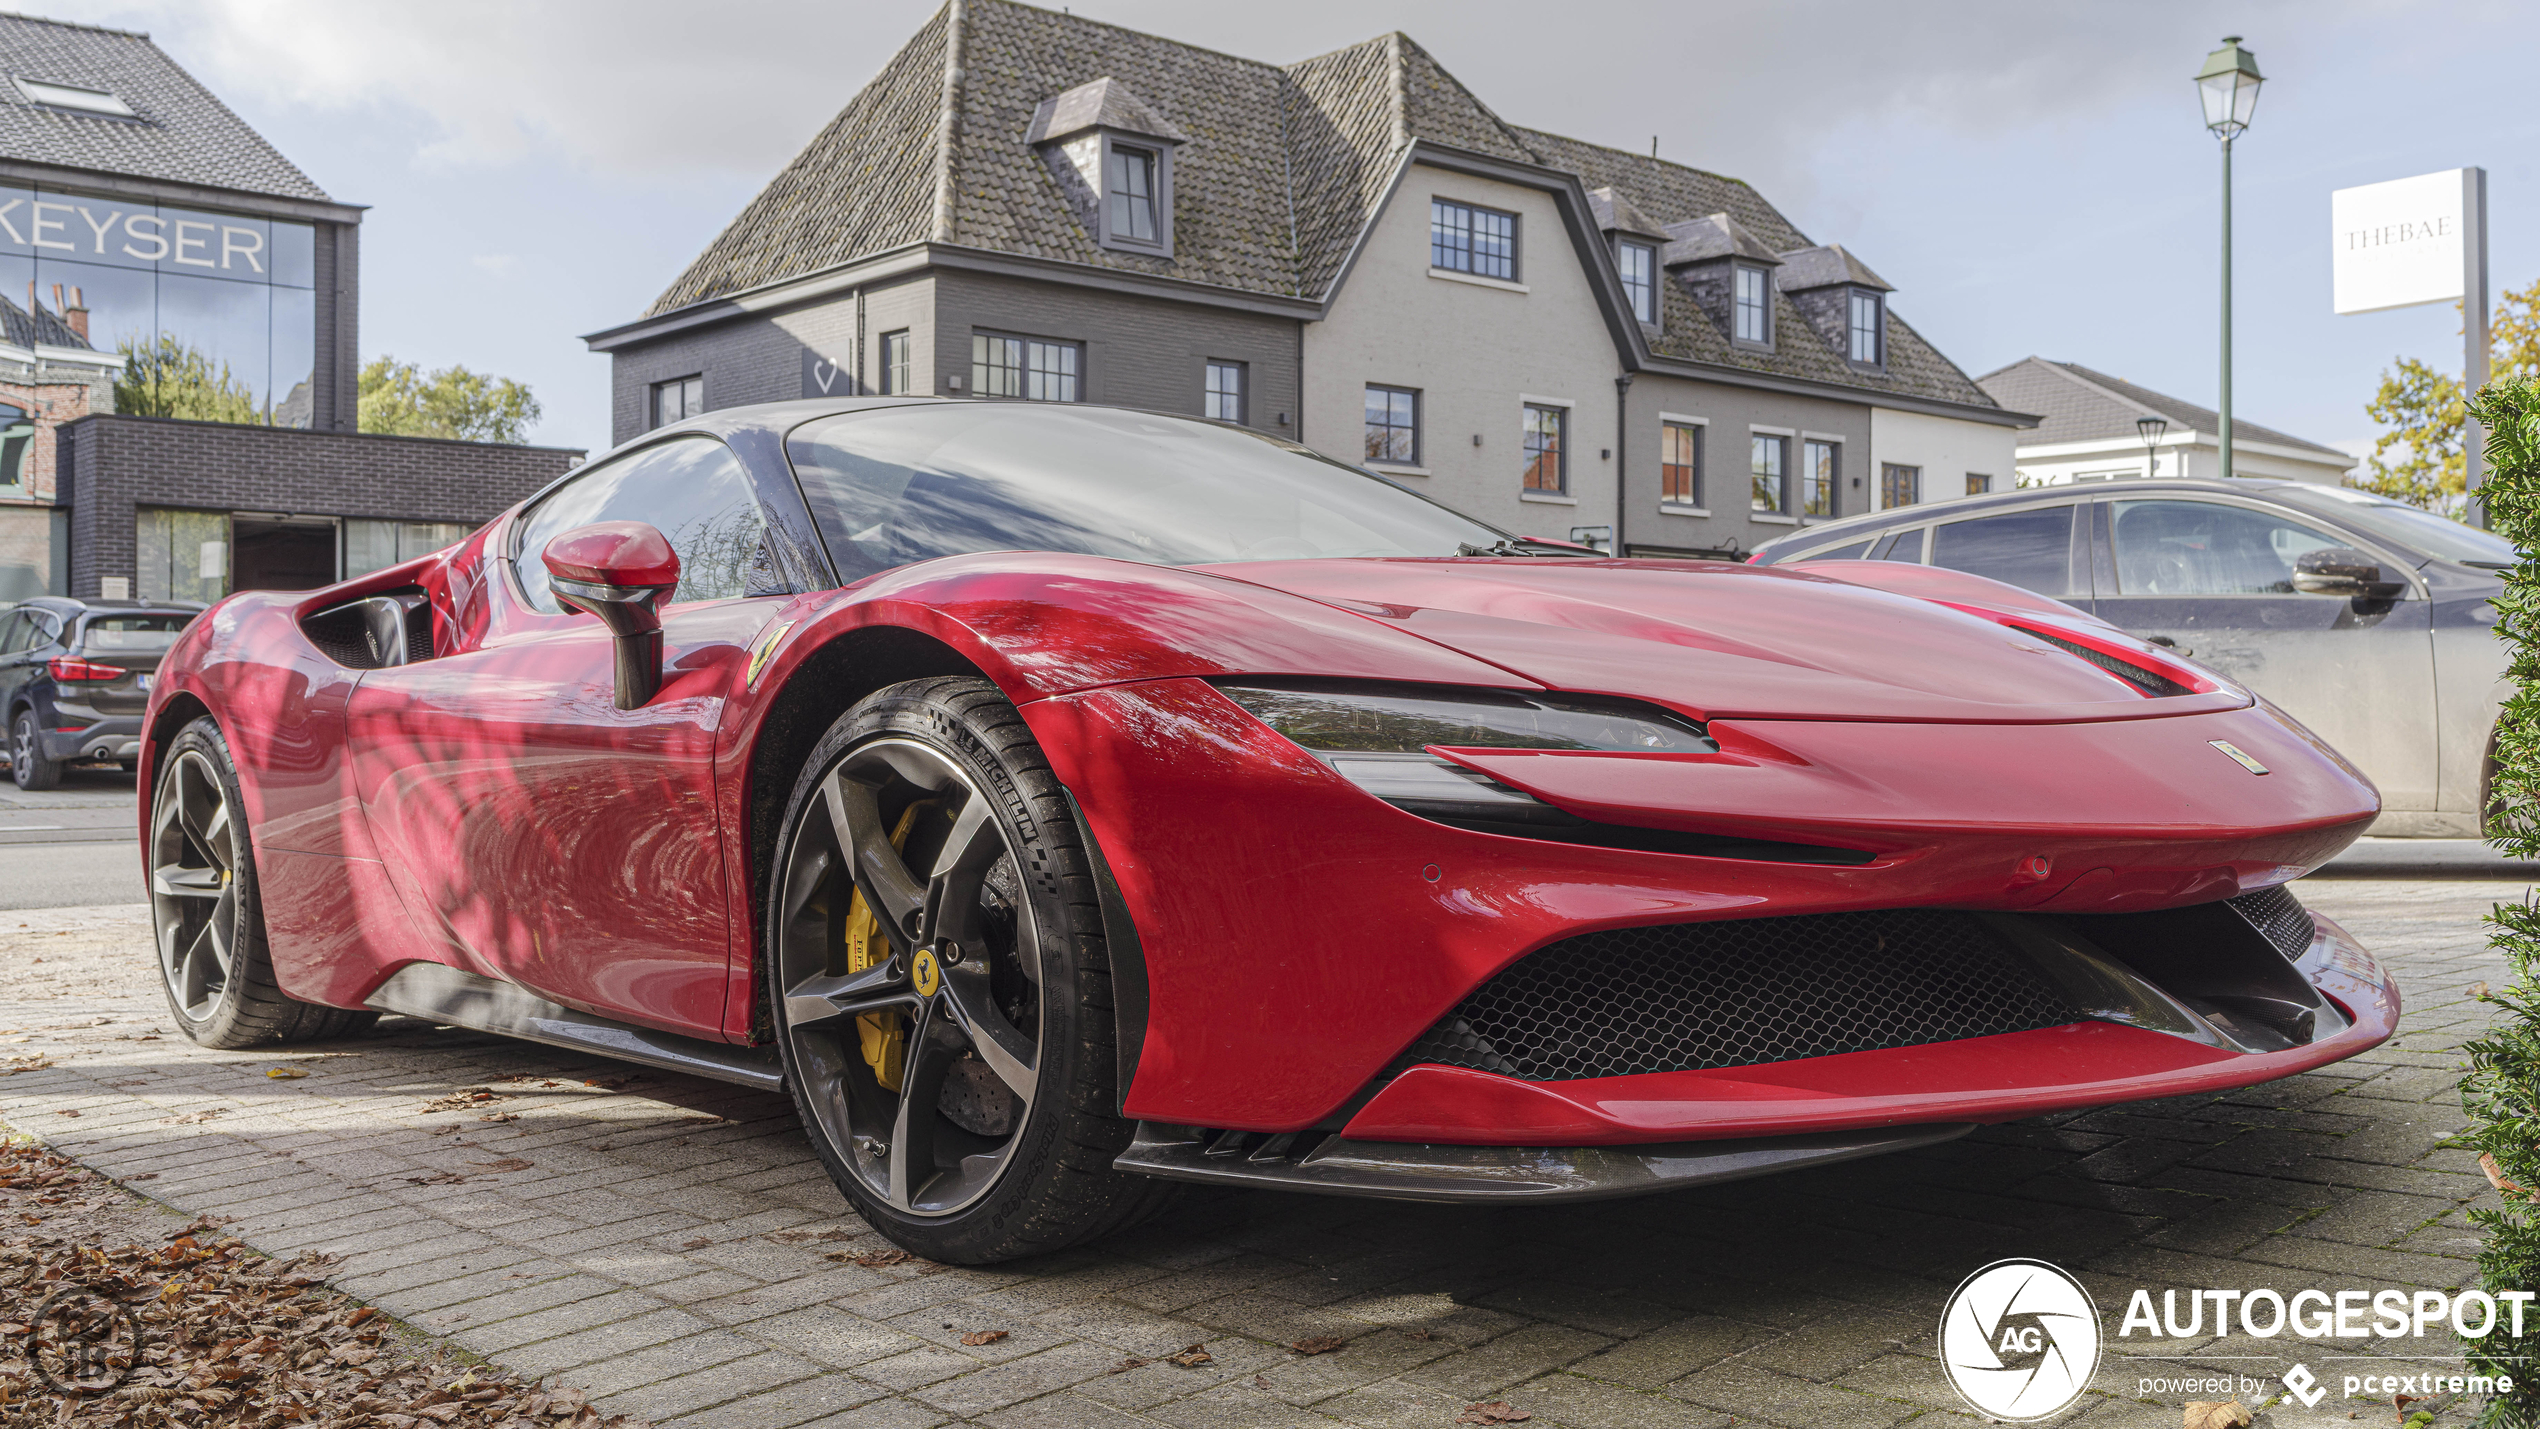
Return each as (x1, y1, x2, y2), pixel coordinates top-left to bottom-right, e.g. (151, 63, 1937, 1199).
(1303, 165, 1615, 538)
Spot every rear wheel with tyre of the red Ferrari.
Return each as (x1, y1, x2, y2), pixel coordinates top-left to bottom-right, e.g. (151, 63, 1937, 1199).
(150, 716, 378, 1048)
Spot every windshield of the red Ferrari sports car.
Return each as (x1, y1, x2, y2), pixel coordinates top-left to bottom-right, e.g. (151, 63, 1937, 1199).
(785, 401, 1506, 581)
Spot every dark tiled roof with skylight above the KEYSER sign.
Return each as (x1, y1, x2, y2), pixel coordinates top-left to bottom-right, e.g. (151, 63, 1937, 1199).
(0, 13, 330, 203)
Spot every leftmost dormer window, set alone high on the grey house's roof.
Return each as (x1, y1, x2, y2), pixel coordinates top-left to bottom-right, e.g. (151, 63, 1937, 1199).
(1024, 79, 1189, 259)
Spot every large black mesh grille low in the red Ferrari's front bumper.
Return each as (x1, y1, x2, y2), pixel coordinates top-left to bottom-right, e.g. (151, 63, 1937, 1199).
(1402, 909, 2080, 1081)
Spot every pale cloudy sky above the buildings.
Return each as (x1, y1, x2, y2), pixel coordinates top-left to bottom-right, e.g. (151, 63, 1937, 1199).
(30, 0, 2540, 459)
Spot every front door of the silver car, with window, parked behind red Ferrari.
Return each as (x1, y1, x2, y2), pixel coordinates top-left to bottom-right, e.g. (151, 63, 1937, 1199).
(2093, 495, 2436, 810)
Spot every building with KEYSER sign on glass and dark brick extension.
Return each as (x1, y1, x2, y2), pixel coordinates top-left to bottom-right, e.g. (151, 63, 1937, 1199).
(0, 15, 579, 602)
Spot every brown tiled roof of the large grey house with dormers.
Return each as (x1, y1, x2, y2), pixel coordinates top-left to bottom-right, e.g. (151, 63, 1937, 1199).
(648, 0, 1994, 406)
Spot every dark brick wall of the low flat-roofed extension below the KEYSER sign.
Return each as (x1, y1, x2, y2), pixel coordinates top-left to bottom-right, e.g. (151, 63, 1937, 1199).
(61, 416, 582, 596)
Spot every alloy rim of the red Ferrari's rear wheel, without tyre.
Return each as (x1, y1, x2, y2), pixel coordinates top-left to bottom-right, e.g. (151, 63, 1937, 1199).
(150, 749, 239, 1020)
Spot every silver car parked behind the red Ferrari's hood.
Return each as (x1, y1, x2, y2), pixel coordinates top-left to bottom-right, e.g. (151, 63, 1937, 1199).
(1753, 477, 2515, 838)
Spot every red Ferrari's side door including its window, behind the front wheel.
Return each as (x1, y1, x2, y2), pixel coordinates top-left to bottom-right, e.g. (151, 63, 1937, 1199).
(348, 437, 780, 1036)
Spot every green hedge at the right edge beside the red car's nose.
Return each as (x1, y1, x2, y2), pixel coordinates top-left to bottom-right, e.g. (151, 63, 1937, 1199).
(2461, 383, 2540, 1429)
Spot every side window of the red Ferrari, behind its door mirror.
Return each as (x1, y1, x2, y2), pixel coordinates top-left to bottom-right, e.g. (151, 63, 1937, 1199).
(513, 437, 767, 614)
